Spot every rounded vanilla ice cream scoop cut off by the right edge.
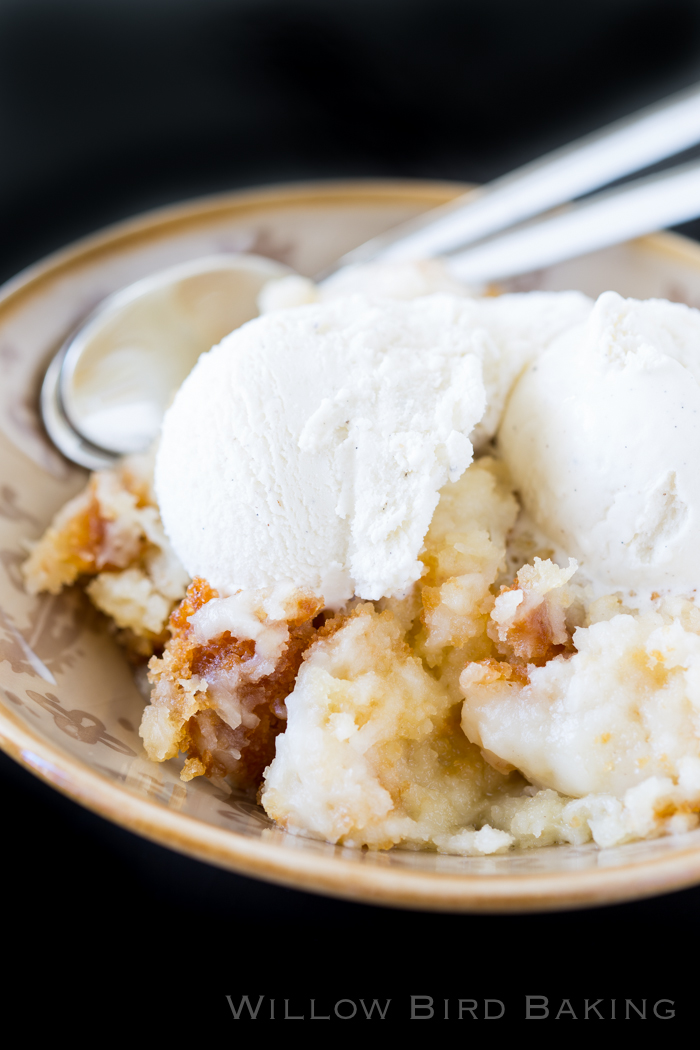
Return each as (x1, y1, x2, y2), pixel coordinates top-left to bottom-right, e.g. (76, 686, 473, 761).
(499, 292, 700, 593)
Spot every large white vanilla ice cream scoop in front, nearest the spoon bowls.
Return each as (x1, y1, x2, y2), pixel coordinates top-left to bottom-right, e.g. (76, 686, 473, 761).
(155, 295, 486, 605)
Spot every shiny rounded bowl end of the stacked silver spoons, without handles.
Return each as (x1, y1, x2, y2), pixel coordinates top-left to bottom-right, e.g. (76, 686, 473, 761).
(41, 254, 293, 469)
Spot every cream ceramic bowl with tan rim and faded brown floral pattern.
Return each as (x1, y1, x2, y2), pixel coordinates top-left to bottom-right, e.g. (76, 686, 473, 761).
(0, 182, 700, 911)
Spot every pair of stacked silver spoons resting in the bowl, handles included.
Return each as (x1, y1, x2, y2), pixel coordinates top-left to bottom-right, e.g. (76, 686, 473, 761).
(41, 81, 700, 469)
